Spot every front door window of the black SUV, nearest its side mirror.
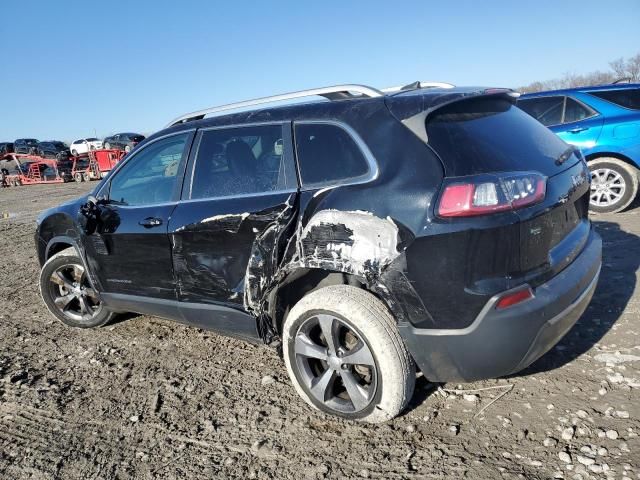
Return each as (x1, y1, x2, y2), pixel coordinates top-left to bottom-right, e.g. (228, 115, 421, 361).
(109, 133, 189, 206)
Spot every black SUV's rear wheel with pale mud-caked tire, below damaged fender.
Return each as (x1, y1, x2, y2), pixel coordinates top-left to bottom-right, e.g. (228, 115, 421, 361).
(283, 285, 416, 423)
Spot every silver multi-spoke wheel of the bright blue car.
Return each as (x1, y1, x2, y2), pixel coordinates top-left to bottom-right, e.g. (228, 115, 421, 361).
(589, 157, 639, 213)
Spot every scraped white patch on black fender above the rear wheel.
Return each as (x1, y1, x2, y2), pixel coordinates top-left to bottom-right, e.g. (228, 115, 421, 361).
(302, 210, 399, 272)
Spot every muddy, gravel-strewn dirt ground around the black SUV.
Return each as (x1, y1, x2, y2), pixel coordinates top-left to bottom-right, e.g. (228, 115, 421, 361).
(0, 183, 640, 479)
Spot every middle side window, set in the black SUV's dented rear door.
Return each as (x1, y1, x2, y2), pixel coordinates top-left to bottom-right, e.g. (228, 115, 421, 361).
(191, 125, 294, 199)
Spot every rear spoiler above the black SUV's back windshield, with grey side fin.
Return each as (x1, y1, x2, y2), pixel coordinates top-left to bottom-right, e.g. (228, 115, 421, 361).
(385, 88, 520, 143)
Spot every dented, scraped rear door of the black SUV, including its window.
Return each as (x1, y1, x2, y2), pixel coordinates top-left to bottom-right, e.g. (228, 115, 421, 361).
(169, 123, 298, 318)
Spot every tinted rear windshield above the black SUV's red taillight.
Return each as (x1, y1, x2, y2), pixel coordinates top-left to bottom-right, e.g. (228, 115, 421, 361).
(426, 98, 570, 176)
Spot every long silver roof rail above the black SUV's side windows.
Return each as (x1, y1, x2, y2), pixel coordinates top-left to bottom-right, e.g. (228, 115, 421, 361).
(165, 84, 384, 128)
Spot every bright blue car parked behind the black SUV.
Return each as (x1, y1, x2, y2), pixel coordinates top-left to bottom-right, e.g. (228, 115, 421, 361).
(518, 84, 640, 213)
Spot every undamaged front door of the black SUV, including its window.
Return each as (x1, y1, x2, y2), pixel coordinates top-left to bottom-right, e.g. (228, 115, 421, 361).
(85, 133, 193, 300)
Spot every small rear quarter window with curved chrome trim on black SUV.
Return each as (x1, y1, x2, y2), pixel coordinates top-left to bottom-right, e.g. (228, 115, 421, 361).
(295, 123, 372, 187)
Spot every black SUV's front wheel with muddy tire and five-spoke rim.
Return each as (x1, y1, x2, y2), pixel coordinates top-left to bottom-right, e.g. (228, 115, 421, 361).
(39, 248, 115, 328)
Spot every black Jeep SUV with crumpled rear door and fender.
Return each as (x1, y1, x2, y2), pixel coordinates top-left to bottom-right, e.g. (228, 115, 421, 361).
(36, 83, 602, 422)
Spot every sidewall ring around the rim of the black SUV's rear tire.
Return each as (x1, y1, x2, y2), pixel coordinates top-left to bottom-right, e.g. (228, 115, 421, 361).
(283, 309, 383, 420)
